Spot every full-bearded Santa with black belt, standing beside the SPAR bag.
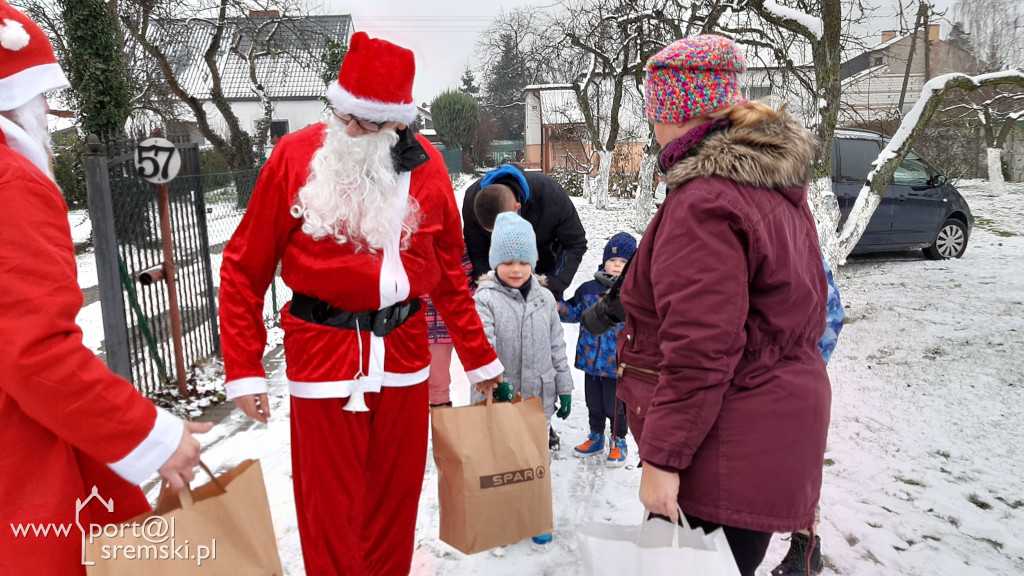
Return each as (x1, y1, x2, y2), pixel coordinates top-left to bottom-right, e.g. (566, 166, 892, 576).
(220, 33, 503, 576)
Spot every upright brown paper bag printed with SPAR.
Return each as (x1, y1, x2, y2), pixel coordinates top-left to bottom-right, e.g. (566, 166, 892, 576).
(430, 398, 552, 553)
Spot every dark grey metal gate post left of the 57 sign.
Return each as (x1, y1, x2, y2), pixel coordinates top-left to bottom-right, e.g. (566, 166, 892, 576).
(82, 134, 133, 381)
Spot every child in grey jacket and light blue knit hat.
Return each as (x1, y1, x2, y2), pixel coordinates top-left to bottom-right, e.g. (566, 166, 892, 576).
(473, 212, 572, 544)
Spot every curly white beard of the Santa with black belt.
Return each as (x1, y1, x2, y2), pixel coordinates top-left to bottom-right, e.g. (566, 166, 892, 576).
(291, 111, 418, 253)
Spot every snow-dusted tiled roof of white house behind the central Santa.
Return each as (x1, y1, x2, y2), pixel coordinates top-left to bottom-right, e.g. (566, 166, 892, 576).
(150, 14, 352, 99)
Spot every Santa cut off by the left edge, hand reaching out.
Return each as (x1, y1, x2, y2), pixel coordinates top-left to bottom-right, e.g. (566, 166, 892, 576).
(0, 0, 210, 576)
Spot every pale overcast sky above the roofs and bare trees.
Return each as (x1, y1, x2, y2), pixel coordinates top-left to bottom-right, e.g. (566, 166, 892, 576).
(310, 0, 953, 104)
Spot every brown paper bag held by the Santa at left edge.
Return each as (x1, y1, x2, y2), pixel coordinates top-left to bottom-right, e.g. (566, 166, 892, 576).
(85, 460, 284, 576)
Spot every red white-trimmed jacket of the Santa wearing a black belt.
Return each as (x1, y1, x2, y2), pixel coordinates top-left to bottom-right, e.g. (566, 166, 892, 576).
(220, 124, 502, 399)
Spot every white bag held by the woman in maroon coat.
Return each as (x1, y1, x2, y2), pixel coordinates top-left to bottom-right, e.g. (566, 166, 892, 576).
(577, 511, 739, 576)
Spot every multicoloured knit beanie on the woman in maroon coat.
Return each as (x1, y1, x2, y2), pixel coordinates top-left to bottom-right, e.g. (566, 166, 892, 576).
(645, 34, 746, 124)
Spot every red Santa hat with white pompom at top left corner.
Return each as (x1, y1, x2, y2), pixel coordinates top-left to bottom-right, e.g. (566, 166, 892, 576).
(0, 0, 69, 111)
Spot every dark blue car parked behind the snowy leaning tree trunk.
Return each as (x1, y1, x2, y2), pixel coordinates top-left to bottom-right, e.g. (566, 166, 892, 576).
(831, 128, 974, 260)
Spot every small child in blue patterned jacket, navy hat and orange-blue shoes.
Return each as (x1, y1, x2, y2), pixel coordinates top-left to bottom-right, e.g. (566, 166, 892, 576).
(558, 232, 637, 466)
